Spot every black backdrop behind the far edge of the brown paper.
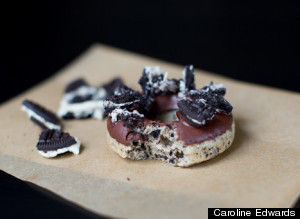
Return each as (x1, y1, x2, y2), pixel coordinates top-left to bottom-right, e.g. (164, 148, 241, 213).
(0, 0, 300, 102)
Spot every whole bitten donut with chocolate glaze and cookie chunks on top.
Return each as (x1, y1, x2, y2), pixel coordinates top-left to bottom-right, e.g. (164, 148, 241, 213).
(103, 65, 235, 167)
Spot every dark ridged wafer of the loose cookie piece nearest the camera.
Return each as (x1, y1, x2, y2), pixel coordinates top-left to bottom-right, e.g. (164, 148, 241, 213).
(36, 129, 77, 152)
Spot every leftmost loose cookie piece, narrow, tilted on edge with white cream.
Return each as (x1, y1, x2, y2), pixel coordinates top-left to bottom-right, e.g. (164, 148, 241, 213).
(21, 100, 61, 129)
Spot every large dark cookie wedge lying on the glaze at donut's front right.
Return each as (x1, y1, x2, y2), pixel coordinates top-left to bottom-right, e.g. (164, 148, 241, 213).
(177, 98, 216, 128)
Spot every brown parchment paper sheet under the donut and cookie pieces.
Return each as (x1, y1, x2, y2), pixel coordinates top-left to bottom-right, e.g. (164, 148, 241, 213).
(0, 44, 300, 218)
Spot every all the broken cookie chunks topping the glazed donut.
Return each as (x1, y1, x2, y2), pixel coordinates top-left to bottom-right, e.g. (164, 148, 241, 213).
(104, 65, 232, 130)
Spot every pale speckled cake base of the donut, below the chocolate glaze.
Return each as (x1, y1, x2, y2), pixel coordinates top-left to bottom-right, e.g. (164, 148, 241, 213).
(107, 122, 235, 167)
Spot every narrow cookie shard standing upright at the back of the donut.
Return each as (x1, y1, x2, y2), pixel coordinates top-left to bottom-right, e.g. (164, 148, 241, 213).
(178, 65, 196, 97)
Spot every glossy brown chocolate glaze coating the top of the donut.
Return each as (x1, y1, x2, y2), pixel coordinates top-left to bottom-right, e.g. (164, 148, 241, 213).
(107, 94, 233, 146)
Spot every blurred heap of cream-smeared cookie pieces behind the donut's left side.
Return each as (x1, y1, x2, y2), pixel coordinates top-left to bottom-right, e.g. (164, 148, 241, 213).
(58, 78, 123, 120)
